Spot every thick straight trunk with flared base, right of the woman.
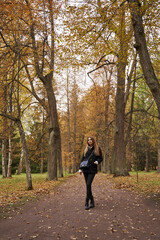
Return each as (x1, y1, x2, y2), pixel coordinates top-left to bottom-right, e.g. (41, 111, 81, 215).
(112, 7, 129, 177)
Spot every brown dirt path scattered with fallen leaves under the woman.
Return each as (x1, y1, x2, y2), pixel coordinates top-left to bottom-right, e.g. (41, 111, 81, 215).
(0, 174, 160, 240)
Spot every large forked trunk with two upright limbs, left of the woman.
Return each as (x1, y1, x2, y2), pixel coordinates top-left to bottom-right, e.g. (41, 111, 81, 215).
(25, 0, 63, 180)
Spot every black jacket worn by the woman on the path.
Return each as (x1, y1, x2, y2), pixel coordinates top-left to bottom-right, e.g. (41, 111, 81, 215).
(81, 147, 103, 173)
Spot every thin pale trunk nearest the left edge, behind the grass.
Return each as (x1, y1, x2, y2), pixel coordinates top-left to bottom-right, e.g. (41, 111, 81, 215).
(2, 138, 7, 178)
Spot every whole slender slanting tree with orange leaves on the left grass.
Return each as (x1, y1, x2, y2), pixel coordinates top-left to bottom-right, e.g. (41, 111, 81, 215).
(0, 2, 33, 190)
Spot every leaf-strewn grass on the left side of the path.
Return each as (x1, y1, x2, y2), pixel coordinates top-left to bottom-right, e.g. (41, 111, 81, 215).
(0, 173, 75, 206)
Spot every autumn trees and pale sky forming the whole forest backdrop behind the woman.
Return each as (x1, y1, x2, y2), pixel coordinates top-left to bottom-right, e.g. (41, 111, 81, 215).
(0, 0, 160, 189)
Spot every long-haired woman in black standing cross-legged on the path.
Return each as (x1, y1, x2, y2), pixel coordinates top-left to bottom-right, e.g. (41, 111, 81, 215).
(79, 137, 103, 210)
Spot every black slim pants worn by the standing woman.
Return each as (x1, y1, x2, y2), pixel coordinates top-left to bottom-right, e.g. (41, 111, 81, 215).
(83, 173, 95, 201)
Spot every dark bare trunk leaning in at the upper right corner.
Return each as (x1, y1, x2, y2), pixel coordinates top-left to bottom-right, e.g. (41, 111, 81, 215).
(128, 0, 160, 115)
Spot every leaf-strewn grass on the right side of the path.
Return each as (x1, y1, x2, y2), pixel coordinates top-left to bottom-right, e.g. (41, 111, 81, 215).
(112, 171, 160, 196)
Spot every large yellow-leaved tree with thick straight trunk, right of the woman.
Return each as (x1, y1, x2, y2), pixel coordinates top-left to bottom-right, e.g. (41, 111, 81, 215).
(62, 1, 159, 176)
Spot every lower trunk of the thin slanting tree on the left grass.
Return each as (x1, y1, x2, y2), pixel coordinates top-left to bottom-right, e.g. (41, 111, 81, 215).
(16, 120, 33, 190)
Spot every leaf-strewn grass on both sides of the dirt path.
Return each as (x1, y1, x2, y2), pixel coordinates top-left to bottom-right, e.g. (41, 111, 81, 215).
(0, 171, 160, 212)
